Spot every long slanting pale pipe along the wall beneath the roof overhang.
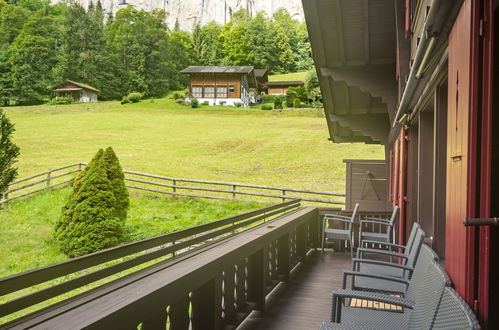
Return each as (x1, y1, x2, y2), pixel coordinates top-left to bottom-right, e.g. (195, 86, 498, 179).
(392, 0, 442, 127)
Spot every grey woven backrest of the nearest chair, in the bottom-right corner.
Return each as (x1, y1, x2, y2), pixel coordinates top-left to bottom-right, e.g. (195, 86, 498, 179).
(432, 287, 480, 329)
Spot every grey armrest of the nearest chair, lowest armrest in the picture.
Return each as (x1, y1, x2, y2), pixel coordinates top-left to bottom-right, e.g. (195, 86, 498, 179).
(331, 289, 415, 323)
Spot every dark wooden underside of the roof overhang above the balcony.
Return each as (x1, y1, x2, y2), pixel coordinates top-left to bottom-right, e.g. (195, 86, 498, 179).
(302, 0, 397, 144)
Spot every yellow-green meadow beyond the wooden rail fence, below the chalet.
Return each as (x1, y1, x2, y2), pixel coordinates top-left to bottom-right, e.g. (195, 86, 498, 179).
(6, 92, 384, 192)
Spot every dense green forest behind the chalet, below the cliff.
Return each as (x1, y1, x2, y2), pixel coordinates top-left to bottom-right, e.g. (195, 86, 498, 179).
(0, 0, 313, 106)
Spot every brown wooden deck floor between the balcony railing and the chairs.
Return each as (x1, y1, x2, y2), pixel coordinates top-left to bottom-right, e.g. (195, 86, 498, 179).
(238, 251, 352, 330)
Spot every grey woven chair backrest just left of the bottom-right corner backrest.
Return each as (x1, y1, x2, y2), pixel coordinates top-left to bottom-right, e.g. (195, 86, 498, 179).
(408, 260, 452, 329)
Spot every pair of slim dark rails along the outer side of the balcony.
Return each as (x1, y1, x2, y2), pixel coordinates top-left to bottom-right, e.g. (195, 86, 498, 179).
(0, 200, 301, 325)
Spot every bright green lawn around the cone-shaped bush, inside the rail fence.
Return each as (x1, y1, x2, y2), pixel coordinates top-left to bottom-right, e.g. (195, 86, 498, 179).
(0, 188, 263, 277)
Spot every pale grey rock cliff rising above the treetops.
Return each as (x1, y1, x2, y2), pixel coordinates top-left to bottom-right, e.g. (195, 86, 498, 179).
(61, 0, 303, 31)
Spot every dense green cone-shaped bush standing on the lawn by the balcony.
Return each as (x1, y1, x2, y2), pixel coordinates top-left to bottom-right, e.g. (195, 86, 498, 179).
(54, 148, 129, 258)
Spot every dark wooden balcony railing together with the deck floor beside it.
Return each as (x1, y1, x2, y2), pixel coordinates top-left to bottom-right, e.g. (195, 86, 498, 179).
(0, 200, 392, 329)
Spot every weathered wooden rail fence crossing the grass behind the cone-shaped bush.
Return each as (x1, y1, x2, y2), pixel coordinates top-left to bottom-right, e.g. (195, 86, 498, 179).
(0, 163, 345, 206)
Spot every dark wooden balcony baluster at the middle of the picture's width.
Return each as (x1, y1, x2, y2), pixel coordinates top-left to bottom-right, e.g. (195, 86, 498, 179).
(247, 249, 265, 311)
